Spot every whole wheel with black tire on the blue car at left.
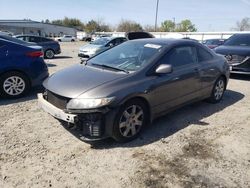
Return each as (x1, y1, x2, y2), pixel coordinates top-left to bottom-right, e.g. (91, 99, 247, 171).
(0, 71, 30, 98)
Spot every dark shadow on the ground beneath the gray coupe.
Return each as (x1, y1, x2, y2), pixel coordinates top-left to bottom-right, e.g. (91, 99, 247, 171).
(84, 90, 244, 149)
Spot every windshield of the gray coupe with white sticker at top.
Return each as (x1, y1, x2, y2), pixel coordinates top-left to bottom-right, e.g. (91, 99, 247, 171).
(87, 41, 162, 72)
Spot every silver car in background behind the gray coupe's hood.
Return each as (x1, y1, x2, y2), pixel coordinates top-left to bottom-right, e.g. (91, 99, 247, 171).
(78, 37, 127, 59)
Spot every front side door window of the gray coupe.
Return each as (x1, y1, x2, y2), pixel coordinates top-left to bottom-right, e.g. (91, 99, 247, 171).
(162, 46, 197, 67)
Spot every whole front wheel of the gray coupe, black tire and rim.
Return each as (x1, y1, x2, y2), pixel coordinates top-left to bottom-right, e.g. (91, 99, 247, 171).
(112, 100, 148, 142)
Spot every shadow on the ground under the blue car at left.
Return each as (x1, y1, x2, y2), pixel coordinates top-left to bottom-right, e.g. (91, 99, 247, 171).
(0, 86, 44, 106)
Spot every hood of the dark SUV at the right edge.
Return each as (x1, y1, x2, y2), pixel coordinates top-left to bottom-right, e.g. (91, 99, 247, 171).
(214, 45, 250, 56)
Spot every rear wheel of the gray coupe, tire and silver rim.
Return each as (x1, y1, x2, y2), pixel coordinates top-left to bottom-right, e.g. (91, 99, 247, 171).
(209, 77, 226, 103)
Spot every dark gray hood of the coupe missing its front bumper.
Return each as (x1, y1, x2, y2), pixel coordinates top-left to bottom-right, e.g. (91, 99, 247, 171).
(43, 64, 127, 98)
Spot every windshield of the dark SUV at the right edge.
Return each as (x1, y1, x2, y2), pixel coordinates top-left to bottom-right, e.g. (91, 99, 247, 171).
(224, 34, 250, 46)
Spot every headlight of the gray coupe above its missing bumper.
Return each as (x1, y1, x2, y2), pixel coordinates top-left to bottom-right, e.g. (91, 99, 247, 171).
(67, 97, 114, 110)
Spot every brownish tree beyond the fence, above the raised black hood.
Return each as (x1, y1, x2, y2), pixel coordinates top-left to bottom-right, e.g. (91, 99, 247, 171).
(117, 20, 143, 32)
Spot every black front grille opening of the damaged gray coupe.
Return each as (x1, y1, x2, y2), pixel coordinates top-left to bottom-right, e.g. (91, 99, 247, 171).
(44, 90, 70, 109)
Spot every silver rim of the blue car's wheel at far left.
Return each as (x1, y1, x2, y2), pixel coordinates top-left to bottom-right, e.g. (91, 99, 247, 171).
(3, 76, 25, 96)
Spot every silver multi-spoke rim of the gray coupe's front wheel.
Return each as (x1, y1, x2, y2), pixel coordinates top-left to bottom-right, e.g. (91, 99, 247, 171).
(119, 105, 144, 137)
